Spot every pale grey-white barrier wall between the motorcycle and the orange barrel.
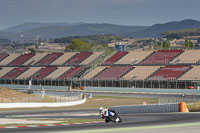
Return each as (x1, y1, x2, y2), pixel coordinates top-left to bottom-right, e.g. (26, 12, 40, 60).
(110, 103, 178, 114)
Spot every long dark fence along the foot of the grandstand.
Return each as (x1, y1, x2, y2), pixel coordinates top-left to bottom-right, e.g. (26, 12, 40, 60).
(0, 79, 199, 89)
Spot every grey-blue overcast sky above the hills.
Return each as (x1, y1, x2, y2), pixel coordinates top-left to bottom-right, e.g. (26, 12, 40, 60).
(0, 0, 200, 29)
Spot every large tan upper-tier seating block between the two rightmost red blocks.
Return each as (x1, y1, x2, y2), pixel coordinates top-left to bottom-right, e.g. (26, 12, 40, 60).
(115, 51, 152, 64)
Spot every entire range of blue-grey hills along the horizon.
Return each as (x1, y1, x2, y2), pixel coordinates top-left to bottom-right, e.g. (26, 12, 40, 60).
(0, 19, 200, 41)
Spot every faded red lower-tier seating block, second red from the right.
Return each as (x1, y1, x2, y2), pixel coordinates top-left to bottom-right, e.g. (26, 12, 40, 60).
(94, 66, 133, 80)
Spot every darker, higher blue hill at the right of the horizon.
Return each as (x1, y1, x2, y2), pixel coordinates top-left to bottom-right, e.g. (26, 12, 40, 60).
(127, 19, 200, 37)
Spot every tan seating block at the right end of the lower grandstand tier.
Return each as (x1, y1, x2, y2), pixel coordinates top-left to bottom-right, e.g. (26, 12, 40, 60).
(179, 66, 200, 80)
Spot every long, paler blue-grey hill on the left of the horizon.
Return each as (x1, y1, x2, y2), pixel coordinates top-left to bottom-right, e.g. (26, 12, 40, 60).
(0, 23, 147, 40)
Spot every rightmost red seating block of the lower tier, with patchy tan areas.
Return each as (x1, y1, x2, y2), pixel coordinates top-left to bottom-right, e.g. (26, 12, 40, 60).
(148, 66, 191, 80)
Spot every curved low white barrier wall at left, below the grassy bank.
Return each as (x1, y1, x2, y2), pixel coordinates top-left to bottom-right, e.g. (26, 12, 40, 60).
(0, 98, 86, 108)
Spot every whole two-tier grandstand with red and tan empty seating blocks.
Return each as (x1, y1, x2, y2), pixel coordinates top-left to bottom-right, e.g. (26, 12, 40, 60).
(0, 50, 200, 88)
